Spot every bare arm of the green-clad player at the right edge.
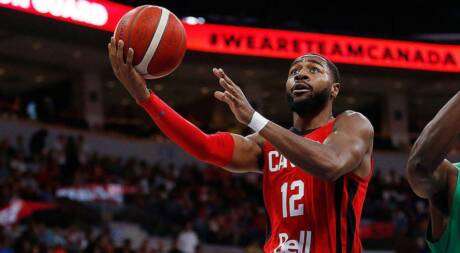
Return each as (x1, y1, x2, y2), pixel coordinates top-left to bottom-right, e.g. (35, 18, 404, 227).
(407, 92, 460, 198)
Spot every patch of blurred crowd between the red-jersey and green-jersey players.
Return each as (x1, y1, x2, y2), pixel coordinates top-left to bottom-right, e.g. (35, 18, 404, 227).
(362, 169, 429, 253)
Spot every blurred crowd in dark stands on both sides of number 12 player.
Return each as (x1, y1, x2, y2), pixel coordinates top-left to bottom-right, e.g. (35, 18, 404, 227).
(0, 130, 427, 253)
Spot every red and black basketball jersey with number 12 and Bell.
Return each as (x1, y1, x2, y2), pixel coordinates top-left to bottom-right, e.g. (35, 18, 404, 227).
(263, 120, 372, 253)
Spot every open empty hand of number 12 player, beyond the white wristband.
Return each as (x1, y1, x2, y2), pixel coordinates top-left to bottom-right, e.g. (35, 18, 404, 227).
(212, 68, 254, 125)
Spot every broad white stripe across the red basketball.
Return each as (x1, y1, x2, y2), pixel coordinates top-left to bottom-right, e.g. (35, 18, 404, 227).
(136, 8, 169, 75)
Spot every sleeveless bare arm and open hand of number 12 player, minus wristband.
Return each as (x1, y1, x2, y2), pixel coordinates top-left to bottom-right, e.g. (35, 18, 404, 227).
(214, 69, 374, 181)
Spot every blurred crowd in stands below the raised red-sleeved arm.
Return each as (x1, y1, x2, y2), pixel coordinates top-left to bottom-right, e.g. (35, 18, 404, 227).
(0, 130, 265, 252)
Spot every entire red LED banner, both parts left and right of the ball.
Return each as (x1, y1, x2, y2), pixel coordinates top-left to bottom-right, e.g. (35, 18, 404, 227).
(0, 0, 460, 73)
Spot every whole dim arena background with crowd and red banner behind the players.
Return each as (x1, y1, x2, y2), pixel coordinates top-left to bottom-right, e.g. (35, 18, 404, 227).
(0, 0, 460, 252)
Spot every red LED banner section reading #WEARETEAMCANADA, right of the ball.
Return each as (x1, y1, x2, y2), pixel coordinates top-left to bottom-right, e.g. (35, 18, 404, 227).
(187, 24, 460, 72)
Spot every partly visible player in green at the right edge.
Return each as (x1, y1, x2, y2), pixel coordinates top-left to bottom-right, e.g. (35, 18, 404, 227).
(407, 92, 460, 253)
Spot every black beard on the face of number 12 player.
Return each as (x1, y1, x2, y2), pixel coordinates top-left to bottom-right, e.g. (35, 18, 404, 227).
(286, 88, 331, 116)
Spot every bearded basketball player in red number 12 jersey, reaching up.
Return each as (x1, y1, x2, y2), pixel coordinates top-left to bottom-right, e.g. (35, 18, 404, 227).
(108, 39, 373, 253)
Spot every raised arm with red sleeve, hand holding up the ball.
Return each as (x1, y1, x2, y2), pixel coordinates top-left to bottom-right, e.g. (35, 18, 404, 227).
(108, 38, 262, 172)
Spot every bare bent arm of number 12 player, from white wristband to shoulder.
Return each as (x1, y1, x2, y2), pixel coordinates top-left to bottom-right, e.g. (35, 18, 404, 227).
(259, 111, 374, 181)
